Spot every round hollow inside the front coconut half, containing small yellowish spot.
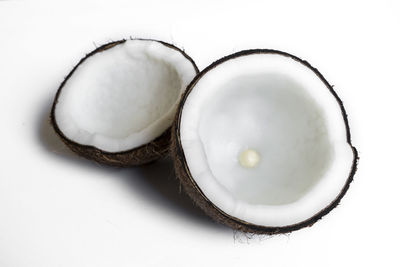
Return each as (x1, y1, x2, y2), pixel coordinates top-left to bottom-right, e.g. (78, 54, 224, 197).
(198, 73, 333, 205)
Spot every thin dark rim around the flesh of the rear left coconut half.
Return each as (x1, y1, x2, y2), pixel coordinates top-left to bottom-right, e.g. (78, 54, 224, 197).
(50, 38, 199, 156)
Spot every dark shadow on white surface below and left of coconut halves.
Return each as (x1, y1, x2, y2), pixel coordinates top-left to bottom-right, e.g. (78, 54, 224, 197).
(36, 98, 230, 231)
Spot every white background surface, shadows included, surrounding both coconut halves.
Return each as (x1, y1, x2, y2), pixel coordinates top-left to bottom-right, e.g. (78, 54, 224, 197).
(0, 0, 400, 267)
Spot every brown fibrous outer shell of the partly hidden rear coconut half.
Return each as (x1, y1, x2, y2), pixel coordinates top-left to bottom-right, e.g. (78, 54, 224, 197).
(50, 39, 199, 167)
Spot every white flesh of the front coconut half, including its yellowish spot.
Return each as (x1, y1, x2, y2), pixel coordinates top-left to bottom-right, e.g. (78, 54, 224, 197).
(180, 54, 353, 227)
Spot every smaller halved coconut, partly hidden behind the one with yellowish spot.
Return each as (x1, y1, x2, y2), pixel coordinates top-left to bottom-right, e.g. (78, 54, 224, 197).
(51, 39, 198, 166)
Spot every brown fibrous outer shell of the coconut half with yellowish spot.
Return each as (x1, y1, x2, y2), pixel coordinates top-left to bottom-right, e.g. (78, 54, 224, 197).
(171, 49, 359, 234)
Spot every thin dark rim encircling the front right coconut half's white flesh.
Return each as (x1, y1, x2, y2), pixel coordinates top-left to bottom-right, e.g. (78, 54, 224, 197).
(172, 49, 359, 234)
